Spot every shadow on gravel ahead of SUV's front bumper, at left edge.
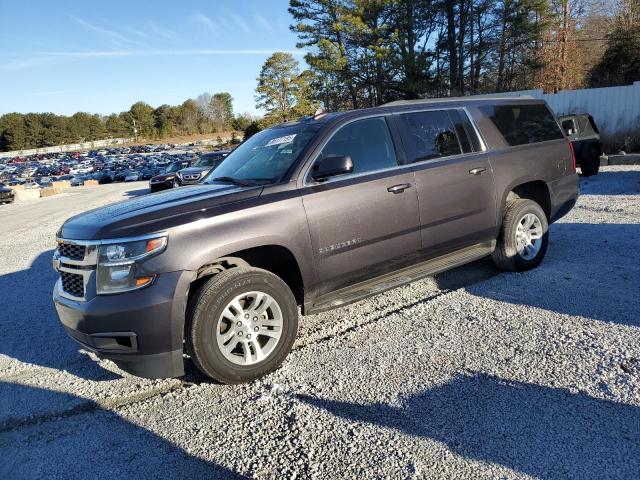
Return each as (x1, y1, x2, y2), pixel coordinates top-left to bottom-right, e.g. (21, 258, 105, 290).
(0, 250, 120, 381)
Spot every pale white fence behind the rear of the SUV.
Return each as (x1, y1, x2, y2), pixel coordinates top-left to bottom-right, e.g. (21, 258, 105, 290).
(490, 81, 640, 137)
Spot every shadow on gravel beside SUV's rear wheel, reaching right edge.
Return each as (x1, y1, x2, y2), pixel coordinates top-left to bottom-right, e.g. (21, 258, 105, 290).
(456, 223, 640, 326)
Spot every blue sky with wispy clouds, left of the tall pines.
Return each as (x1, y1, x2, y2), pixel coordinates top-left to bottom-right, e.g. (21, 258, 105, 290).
(0, 0, 304, 115)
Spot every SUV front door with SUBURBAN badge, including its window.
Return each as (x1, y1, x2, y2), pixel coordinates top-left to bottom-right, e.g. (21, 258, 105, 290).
(302, 116, 420, 294)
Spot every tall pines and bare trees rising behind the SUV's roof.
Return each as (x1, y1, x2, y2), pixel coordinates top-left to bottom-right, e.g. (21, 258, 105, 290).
(282, 0, 640, 110)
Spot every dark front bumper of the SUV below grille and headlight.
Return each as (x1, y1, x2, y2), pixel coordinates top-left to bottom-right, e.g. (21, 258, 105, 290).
(53, 272, 193, 378)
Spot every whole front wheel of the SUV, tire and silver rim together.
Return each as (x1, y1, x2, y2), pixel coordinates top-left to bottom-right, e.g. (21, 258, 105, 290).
(185, 267, 298, 383)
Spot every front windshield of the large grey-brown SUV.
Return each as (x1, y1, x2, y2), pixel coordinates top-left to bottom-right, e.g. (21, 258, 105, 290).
(204, 122, 321, 184)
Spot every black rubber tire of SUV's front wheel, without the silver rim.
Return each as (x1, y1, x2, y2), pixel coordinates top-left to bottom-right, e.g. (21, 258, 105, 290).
(189, 269, 298, 383)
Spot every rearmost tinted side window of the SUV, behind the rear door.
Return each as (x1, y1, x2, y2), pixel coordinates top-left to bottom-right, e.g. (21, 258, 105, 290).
(480, 104, 564, 146)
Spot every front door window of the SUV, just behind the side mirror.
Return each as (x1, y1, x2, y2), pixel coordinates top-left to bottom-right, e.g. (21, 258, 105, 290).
(320, 117, 398, 174)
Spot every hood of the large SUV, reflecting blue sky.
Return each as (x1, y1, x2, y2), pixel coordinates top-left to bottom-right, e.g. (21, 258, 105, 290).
(58, 185, 263, 240)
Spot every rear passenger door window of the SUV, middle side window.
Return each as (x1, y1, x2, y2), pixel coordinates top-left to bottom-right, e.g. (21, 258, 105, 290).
(399, 110, 468, 163)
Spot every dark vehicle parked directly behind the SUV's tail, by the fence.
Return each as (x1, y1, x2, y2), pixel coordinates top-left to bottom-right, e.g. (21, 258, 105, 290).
(558, 113, 602, 177)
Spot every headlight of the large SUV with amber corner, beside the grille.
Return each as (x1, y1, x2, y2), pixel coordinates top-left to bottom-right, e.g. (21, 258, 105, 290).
(96, 236, 167, 295)
